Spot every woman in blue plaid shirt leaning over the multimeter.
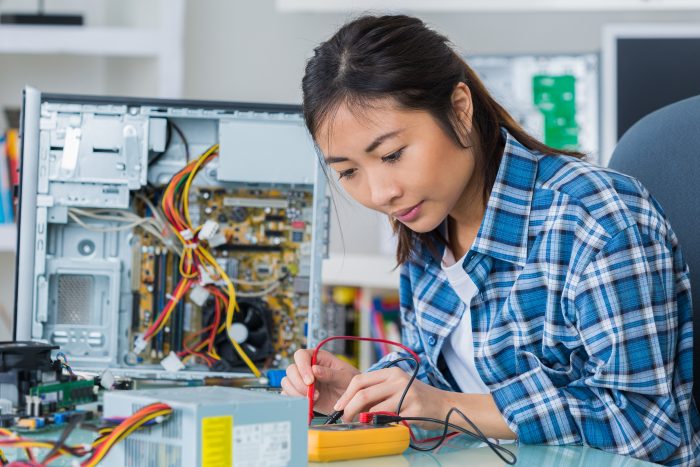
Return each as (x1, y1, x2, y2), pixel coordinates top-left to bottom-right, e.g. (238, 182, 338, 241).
(282, 12, 700, 465)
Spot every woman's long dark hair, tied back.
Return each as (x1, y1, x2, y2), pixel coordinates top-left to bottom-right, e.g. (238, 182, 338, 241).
(302, 15, 582, 264)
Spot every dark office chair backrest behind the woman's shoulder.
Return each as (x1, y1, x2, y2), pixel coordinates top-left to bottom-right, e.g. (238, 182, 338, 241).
(609, 96, 700, 407)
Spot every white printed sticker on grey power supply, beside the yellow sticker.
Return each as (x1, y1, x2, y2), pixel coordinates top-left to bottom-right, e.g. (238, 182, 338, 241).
(233, 421, 292, 467)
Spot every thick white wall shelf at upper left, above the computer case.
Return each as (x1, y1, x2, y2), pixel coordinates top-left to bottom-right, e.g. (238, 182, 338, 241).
(0, 25, 164, 57)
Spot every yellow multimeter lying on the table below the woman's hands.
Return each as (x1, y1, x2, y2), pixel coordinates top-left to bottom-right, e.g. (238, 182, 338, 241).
(309, 423, 410, 462)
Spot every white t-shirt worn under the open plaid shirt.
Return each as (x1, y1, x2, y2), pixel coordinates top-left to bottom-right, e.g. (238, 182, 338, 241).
(441, 248, 490, 394)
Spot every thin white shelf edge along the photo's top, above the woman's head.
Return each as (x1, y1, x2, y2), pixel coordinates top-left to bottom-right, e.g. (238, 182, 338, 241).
(276, 0, 700, 13)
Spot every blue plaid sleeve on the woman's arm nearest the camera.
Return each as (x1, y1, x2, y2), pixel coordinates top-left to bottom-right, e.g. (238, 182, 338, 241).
(492, 225, 692, 461)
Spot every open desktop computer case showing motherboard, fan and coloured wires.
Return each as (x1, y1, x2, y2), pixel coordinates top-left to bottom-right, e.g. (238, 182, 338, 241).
(15, 88, 329, 378)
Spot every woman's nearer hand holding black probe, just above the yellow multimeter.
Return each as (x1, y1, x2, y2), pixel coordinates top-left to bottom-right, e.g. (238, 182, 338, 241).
(333, 367, 451, 429)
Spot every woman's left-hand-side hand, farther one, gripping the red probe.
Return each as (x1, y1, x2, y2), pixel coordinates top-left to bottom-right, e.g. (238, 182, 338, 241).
(282, 349, 360, 413)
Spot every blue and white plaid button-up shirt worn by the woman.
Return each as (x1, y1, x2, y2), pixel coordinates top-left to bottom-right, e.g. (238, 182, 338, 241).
(371, 128, 700, 465)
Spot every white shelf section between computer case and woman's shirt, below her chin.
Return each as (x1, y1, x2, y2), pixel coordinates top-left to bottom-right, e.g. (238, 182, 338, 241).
(321, 254, 399, 290)
